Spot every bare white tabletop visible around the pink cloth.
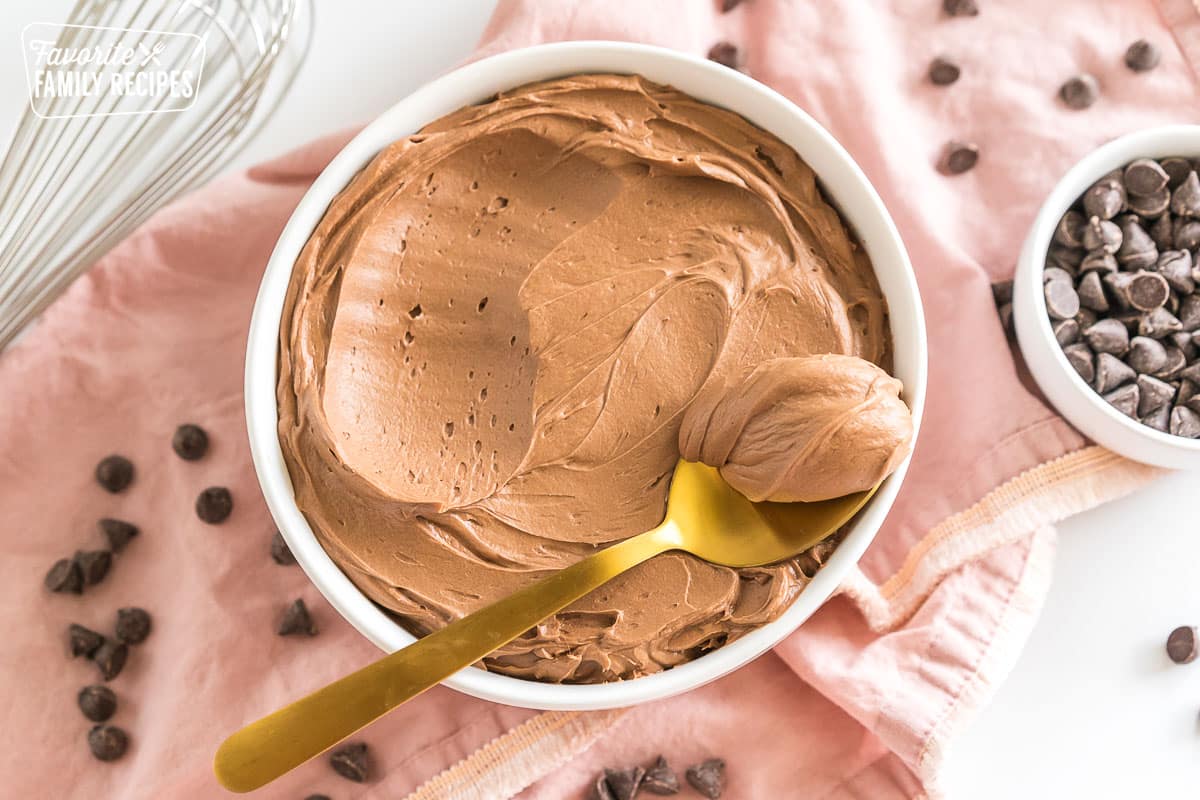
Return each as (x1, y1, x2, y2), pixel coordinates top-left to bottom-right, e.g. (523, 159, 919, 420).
(0, 0, 1200, 800)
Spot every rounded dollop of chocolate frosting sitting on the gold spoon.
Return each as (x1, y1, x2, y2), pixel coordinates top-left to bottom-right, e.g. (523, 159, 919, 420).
(679, 354, 913, 503)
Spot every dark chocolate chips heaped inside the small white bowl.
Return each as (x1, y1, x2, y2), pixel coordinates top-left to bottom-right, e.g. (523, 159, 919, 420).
(1043, 158, 1200, 439)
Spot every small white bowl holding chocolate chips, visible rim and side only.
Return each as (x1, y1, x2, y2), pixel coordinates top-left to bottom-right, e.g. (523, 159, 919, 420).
(1013, 125, 1200, 469)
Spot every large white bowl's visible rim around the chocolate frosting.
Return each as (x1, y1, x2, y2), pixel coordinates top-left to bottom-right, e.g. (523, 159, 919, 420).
(246, 42, 926, 710)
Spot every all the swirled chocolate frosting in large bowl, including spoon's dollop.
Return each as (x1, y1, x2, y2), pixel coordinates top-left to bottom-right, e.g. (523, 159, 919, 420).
(278, 74, 911, 682)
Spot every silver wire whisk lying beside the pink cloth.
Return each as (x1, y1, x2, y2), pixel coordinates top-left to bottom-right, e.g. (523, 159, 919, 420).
(0, 0, 312, 349)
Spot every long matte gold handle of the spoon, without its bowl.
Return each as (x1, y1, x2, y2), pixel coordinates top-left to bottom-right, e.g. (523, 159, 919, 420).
(212, 522, 679, 792)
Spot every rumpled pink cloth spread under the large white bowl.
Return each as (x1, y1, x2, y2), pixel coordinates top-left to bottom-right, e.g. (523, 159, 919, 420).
(0, 0, 1200, 800)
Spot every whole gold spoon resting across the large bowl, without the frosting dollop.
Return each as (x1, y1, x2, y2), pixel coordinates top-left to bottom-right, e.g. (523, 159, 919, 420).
(212, 462, 875, 792)
